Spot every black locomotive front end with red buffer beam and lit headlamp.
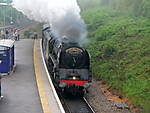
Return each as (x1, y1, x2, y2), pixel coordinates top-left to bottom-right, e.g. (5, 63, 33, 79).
(58, 47, 92, 94)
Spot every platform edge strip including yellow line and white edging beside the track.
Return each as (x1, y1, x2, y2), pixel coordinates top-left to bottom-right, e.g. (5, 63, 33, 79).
(34, 40, 64, 113)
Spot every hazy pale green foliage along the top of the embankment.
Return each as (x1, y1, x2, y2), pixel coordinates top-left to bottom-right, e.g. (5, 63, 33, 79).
(78, 0, 150, 18)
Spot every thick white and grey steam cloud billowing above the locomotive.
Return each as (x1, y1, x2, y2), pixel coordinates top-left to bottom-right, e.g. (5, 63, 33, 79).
(13, 0, 86, 42)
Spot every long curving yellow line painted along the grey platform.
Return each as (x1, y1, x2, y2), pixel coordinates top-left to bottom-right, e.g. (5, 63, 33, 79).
(34, 41, 51, 113)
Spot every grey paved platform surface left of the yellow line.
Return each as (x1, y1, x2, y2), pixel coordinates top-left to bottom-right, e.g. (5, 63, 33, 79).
(0, 39, 43, 113)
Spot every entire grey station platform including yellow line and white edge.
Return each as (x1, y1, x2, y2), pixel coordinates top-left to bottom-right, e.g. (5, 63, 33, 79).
(0, 39, 64, 113)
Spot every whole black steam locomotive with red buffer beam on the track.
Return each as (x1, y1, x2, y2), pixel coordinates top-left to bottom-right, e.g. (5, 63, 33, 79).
(42, 26, 92, 95)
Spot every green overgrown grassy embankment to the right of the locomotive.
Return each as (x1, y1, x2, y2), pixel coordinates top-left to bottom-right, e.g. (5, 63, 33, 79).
(80, 0, 150, 113)
